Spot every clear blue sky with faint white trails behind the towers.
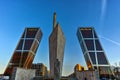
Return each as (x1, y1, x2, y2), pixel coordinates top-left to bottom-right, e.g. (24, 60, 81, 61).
(0, 0, 120, 75)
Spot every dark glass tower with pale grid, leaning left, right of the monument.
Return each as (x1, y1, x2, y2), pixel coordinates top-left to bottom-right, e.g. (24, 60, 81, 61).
(77, 27, 113, 78)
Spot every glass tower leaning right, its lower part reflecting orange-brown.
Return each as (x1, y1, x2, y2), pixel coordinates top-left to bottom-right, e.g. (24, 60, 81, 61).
(4, 28, 42, 76)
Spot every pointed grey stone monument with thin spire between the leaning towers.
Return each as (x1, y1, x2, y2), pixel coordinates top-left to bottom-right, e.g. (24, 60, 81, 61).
(49, 13, 65, 78)
